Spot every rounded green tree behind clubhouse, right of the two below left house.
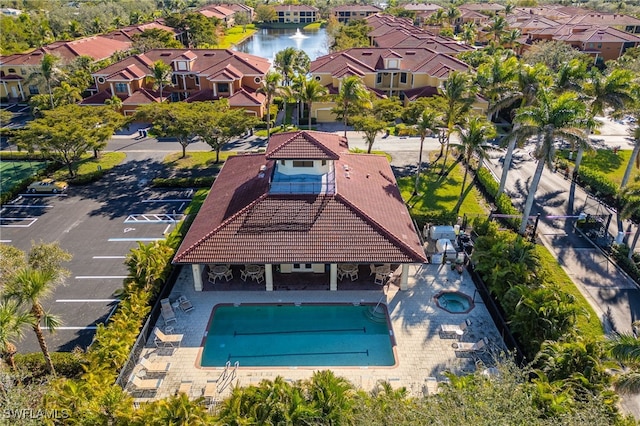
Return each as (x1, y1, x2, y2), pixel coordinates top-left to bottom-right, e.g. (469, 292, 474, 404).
(196, 99, 258, 164)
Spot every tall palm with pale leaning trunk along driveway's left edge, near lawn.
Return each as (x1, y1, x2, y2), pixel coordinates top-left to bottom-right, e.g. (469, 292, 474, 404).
(495, 64, 553, 198)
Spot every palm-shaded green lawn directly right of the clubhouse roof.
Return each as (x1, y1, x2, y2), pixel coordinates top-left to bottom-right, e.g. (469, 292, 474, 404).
(398, 152, 489, 220)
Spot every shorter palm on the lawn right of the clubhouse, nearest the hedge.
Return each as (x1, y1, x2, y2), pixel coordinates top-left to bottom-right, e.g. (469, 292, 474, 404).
(456, 115, 496, 208)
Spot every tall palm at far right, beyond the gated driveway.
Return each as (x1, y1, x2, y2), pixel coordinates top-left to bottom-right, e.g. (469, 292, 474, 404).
(574, 67, 634, 174)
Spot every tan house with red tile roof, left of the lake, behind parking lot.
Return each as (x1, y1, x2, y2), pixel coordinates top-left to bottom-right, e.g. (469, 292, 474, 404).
(82, 49, 271, 117)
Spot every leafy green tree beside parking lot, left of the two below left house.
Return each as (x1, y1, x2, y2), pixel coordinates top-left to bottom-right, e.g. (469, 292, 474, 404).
(135, 102, 198, 158)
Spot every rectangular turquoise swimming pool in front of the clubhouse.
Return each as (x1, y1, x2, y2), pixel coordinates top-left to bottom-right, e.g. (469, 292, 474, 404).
(200, 304, 395, 367)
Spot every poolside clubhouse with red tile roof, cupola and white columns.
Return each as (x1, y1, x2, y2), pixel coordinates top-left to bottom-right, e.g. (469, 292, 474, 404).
(173, 131, 426, 291)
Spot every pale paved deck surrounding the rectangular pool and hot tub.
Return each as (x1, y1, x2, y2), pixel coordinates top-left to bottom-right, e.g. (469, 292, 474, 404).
(133, 264, 504, 401)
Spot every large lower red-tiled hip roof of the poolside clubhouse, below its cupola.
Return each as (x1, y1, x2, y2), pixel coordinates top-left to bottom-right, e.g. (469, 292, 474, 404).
(174, 135, 425, 264)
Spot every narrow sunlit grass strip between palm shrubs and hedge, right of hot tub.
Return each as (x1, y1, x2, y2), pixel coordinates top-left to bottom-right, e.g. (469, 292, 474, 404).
(535, 245, 604, 339)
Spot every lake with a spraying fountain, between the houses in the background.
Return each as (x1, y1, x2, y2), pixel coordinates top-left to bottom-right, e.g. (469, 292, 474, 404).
(234, 28, 329, 62)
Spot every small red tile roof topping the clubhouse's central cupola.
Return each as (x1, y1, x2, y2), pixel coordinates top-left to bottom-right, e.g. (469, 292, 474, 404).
(265, 131, 349, 160)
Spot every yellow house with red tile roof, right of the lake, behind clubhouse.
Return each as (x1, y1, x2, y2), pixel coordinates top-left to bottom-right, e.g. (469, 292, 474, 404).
(310, 47, 488, 122)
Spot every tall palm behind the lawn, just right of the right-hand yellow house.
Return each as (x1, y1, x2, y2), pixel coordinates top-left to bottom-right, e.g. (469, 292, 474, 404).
(439, 71, 475, 175)
